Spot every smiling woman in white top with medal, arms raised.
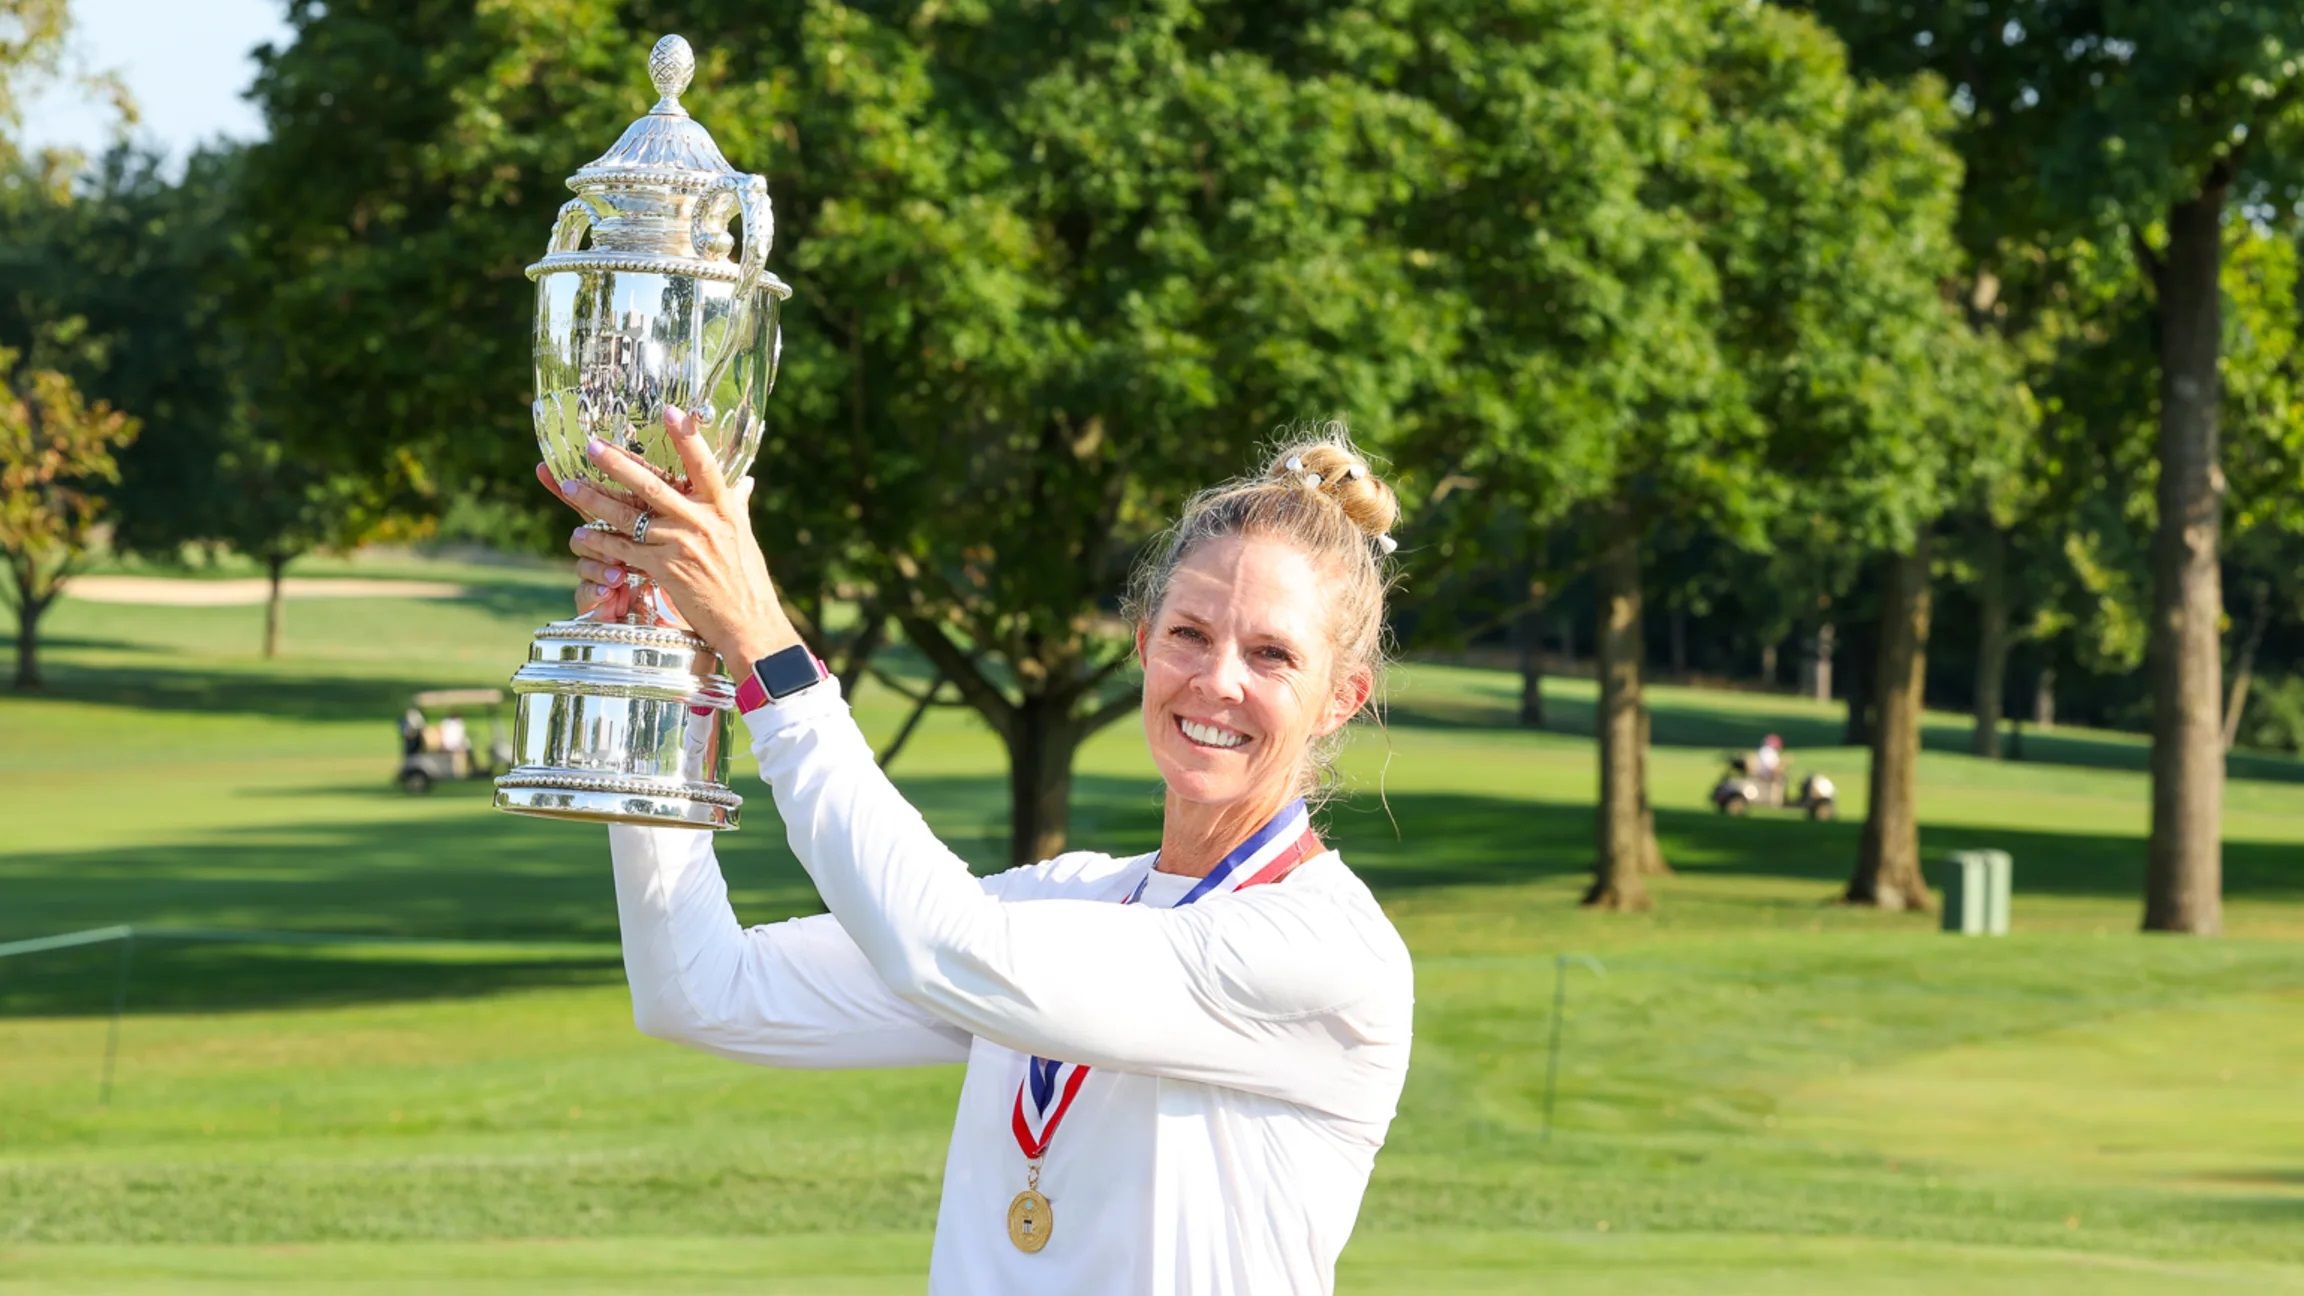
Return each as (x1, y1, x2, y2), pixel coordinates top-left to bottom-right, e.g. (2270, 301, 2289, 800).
(552, 410, 1412, 1296)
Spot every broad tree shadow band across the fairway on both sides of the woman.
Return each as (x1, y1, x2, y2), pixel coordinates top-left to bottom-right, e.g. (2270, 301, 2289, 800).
(18, 747, 2304, 1012)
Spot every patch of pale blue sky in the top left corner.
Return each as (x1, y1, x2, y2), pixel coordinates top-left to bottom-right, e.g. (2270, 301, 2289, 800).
(23, 0, 288, 161)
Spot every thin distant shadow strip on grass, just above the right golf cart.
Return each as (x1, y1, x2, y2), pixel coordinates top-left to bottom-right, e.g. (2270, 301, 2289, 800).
(1387, 671, 2304, 782)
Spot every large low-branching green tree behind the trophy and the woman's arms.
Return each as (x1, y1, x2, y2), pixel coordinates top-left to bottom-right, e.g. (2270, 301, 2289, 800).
(251, 0, 1438, 858)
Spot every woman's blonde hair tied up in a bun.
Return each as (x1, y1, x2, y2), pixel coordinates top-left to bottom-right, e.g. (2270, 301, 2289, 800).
(1122, 422, 1401, 800)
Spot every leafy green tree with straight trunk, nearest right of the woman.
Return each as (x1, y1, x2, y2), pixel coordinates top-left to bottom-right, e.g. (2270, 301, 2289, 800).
(1354, 2, 2009, 909)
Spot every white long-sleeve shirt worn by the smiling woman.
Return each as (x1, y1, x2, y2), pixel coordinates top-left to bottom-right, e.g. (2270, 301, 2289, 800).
(611, 680, 1412, 1296)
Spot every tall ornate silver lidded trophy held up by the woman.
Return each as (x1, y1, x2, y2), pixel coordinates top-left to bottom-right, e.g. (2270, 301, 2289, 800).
(495, 37, 793, 828)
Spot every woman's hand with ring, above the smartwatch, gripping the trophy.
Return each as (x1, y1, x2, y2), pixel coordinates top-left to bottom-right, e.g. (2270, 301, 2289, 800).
(546, 410, 799, 671)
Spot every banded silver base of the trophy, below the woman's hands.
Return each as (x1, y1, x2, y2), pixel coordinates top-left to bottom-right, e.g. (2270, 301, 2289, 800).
(495, 618, 744, 830)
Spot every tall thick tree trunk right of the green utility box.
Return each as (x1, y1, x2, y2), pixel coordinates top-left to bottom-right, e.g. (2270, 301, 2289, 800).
(2145, 180, 2223, 936)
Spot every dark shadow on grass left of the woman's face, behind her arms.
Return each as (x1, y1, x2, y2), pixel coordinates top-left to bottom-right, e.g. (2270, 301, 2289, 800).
(0, 760, 1073, 1015)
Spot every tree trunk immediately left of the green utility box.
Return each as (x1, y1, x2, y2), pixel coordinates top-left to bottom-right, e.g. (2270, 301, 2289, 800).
(1846, 533, 1928, 909)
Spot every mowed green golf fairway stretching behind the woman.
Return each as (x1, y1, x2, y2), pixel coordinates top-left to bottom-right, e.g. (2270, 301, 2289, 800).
(0, 548, 2304, 1296)
